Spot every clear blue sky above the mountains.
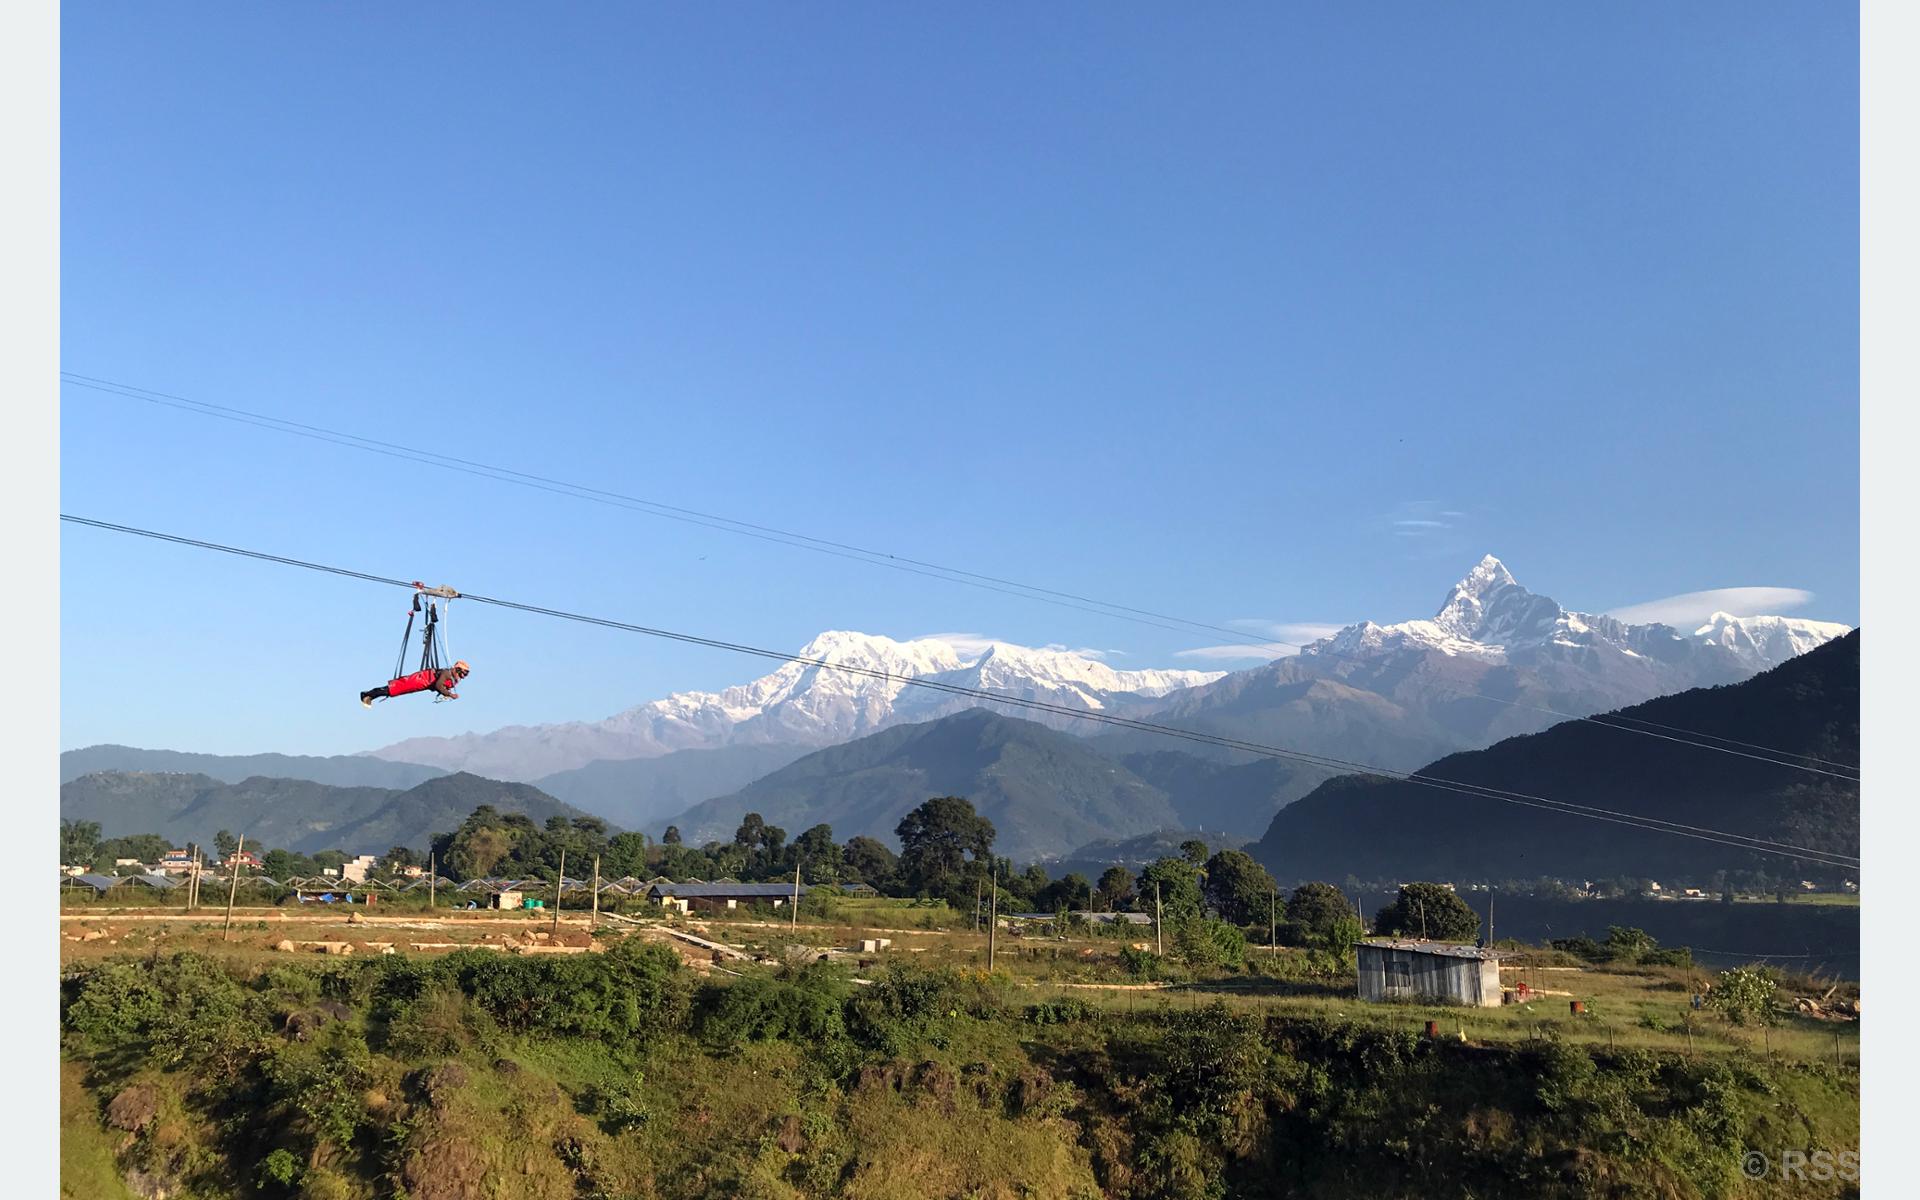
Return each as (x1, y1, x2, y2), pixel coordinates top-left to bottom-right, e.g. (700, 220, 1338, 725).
(60, 2, 1859, 753)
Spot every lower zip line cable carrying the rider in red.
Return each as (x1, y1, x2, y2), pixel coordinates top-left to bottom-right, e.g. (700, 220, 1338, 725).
(60, 513, 1859, 870)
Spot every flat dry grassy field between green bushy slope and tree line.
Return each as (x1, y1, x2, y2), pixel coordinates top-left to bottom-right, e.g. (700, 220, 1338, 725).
(61, 900, 1860, 1066)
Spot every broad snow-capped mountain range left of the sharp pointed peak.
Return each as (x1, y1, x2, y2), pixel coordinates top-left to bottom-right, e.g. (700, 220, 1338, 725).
(372, 630, 1223, 780)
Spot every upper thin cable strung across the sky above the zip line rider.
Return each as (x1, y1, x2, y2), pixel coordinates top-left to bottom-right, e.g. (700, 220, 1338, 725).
(60, 371, 1859, 781)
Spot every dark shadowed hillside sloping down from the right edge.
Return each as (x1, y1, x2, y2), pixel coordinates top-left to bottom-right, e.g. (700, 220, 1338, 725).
(1248, 630, 1860, 881)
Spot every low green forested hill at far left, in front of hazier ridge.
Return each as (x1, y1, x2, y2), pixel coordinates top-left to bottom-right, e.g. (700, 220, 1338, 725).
(60, 772, 588, 854)
